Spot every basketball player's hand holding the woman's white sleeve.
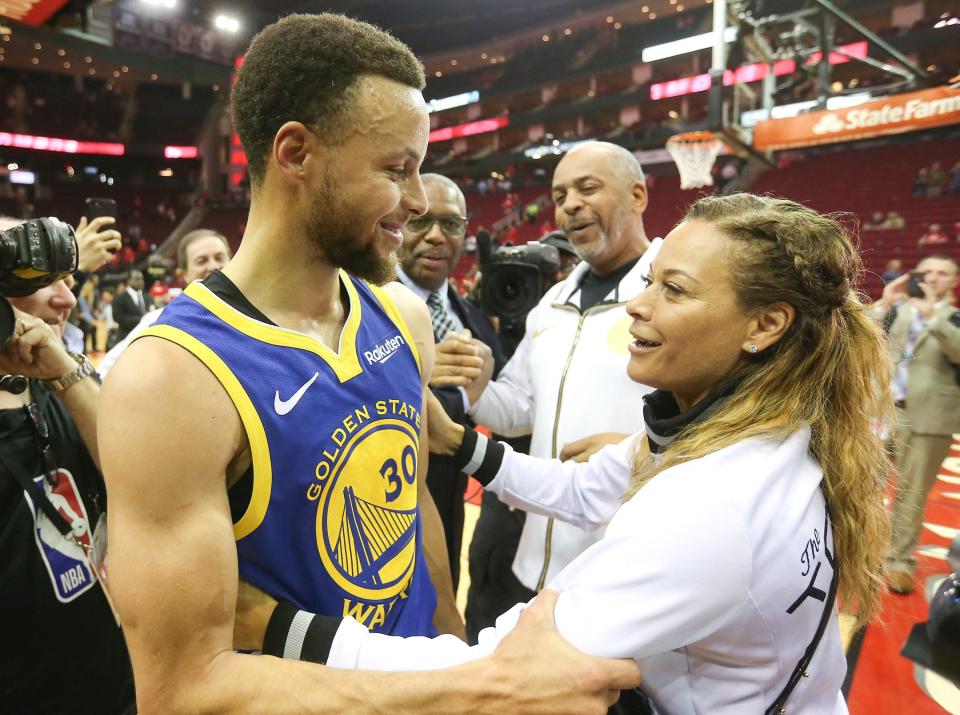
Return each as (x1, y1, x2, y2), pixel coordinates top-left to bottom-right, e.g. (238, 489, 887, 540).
(492, 591, 640, 715)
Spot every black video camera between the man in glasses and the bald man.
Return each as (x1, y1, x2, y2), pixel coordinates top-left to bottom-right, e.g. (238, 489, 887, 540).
(478, 237, 560, 319)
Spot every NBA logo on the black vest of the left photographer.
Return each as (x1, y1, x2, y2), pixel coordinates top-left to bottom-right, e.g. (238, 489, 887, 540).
(24, 469, 94, 603)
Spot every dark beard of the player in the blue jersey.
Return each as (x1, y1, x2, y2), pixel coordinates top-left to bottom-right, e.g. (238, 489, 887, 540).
(307, 181, 397, 285)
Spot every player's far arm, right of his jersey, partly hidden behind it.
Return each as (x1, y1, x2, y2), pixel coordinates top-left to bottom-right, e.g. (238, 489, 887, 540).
(386, 283, 465, 637)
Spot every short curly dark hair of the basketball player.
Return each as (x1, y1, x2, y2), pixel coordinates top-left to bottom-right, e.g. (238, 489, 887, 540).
(231, 13, 425, 185)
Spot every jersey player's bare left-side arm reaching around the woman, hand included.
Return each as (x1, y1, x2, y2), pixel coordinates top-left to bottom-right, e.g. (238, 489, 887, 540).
(100, 338, 638, 715)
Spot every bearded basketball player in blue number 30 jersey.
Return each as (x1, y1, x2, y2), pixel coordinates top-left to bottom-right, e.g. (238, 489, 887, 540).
(98, 15, 636, 713)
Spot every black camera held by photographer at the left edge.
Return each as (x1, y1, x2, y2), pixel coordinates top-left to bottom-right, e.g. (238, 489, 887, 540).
(0, 218, 77, 348)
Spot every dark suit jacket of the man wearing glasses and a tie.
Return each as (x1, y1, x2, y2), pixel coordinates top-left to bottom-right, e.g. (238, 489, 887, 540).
(427, 285, 507, 591)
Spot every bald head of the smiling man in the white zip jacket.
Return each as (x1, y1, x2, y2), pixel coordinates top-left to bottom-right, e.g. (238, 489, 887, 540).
(552, 141, 649, 275)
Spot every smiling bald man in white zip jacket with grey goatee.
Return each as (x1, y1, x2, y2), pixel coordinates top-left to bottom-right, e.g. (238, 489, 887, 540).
(446, 142, 660, 684)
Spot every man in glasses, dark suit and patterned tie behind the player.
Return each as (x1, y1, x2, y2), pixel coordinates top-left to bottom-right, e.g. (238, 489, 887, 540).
(397, 174, 506, 589)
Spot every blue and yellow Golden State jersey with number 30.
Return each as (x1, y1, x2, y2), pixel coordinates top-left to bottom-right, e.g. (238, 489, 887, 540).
(144, 272, 436, 636)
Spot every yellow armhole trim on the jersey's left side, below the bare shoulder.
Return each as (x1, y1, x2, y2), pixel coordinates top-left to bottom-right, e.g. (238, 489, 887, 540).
(140, 324, 273, 541)
